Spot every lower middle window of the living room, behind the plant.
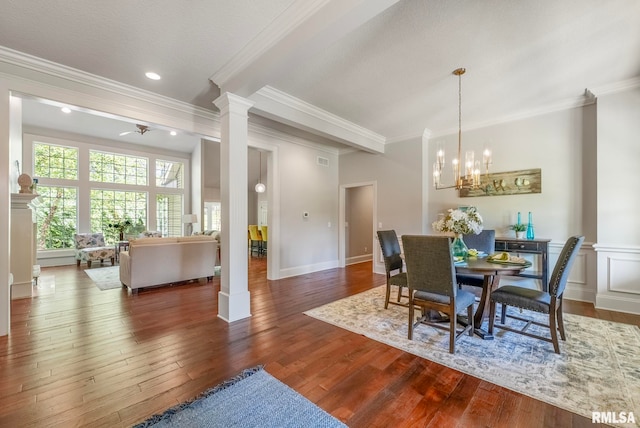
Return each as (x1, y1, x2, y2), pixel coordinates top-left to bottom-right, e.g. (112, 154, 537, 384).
(90, 189, 147, 242)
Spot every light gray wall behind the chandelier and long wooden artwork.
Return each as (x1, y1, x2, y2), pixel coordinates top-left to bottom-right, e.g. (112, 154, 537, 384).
(426, 105, 596, 242)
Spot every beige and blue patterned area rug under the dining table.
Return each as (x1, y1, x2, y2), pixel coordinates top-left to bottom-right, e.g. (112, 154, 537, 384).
(305, 286, 640, 426)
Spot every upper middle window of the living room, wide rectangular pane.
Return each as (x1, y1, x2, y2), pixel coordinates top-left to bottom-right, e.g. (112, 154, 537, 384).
(89, 150, 149, 186)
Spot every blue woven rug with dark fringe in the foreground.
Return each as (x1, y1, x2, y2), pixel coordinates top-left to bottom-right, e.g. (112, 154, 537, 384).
(134, 366, 346, 428)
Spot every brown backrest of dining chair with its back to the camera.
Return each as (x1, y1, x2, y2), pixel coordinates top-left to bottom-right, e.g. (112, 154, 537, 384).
(402, 235, 458, 297)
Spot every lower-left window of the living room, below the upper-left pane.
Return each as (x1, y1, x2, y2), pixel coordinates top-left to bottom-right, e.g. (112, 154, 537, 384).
(35, 186, 78, 250)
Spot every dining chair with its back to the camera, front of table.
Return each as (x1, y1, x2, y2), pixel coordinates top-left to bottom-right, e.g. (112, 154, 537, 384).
(402, 235, 475, 354)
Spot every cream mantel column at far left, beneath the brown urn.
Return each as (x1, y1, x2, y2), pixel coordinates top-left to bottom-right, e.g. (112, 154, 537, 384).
(10, 193, 38, 300)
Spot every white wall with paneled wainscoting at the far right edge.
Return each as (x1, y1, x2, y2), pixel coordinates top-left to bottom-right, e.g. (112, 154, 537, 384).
(596, 88, 640, 313)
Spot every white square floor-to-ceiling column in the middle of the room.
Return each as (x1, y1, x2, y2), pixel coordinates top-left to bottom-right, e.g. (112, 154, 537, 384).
(214, 92, 253, 322)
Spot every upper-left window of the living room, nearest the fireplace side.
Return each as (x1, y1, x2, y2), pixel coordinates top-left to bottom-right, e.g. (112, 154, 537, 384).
(33, 143, 78, 180)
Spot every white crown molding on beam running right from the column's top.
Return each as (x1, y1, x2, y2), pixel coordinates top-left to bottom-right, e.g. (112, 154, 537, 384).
(250, 86, 386, 153)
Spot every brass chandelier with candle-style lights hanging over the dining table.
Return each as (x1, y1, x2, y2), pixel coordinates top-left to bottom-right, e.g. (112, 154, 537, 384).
(433, 68, 491, 190)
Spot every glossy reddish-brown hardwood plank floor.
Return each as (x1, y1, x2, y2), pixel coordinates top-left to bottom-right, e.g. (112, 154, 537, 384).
(0, 258, 640, 427)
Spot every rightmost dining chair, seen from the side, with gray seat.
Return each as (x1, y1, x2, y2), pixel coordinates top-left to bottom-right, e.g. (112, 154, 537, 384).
(489, 236, 584, 354)
